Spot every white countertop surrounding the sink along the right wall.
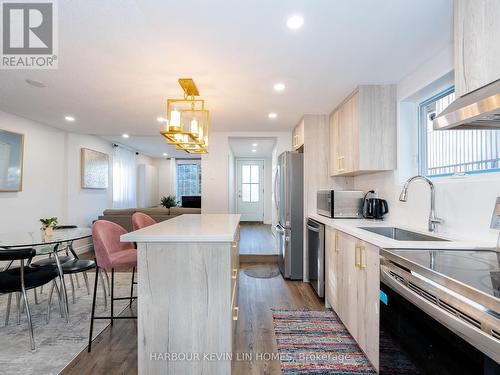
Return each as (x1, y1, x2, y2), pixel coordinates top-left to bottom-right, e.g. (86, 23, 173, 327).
(308, 214, 495, 250)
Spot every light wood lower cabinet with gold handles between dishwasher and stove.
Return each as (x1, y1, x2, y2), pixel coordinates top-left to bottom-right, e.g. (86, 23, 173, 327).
(325, 231, 380, 371)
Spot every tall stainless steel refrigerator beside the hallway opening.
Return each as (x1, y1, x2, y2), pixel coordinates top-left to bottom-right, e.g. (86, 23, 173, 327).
(274, 151, 304, 280)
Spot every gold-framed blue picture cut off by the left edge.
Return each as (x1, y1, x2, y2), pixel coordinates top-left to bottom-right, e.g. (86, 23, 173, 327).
(0, 129, 24, 192)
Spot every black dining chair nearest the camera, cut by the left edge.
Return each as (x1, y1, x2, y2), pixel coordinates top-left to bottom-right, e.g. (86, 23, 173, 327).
(0, 249, 59, 350)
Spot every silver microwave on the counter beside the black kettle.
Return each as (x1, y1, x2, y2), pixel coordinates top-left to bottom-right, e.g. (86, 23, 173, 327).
(316, 190, 364, 219)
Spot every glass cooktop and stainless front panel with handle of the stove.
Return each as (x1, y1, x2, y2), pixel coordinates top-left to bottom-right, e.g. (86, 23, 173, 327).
(380, 249, 500, 369)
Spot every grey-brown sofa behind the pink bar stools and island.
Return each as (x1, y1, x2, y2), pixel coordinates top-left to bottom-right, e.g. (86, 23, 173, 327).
(99, 207, 201, 232)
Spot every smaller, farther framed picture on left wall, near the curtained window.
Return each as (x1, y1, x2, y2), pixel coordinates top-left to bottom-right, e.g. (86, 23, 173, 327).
(81, 148, 109, 189)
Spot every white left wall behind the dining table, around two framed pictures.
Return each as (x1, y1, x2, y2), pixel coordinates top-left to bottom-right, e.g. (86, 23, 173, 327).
(0, 111, 112, 254)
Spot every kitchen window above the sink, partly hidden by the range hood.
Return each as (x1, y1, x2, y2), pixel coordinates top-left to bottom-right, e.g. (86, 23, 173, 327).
(419, 88, 500, 177)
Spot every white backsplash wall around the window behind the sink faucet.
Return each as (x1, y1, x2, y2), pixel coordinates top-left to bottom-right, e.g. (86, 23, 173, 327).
(354, 45, 500, 243)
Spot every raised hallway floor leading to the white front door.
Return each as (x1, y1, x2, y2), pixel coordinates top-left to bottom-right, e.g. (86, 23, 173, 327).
(240, 221, 278, 254)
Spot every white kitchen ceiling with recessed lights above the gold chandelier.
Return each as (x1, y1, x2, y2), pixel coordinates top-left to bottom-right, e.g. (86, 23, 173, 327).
(0, 0, 452, 153)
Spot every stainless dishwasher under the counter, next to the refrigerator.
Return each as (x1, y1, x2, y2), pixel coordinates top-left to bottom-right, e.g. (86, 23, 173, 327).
(306, 219, 325, 297)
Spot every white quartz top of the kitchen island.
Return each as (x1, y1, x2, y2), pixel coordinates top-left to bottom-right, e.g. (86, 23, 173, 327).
(120, 214, 240, 242)
